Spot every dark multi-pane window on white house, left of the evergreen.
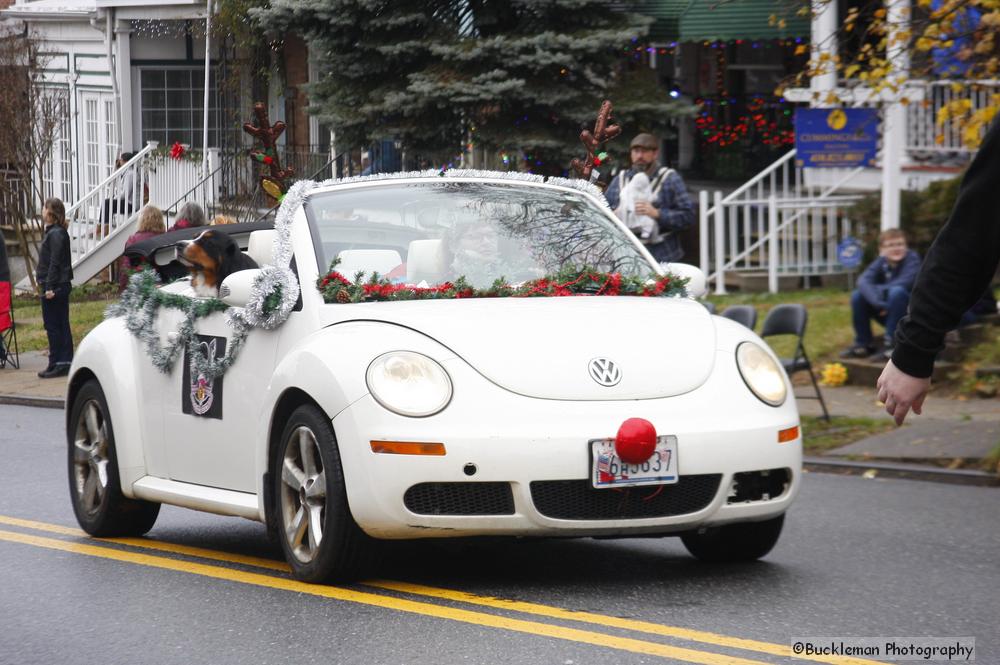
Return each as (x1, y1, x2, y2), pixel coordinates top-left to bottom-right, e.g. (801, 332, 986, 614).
(139, 69, 220, 149)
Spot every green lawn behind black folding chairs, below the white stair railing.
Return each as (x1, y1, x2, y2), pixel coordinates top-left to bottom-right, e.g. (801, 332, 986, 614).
(707, 289, 852, 364)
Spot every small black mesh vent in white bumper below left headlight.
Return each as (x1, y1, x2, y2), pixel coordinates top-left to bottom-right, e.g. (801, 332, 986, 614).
(403, 483, 514, 515)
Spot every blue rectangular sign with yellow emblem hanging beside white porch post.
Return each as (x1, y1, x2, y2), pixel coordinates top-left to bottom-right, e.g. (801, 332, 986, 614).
(795, 109, 879, 168)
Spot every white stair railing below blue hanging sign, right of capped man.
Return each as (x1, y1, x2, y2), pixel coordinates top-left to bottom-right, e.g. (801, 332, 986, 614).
(699, 150, 863, 294)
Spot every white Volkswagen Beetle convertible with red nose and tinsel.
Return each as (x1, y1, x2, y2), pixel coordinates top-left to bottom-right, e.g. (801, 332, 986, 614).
(66, 172, 802, 581)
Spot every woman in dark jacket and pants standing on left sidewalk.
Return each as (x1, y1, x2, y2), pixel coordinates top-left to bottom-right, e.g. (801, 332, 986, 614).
(35, 198, 73, 379)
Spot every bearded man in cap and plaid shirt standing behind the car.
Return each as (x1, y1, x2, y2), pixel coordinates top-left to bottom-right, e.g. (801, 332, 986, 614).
(604, 133, 695, 262)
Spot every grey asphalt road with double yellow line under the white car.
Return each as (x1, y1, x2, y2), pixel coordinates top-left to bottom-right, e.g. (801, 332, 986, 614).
(0, 406, 1000, 665)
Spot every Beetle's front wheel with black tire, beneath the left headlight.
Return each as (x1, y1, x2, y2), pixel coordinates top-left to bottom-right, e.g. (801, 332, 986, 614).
(274, 404, 373, 582)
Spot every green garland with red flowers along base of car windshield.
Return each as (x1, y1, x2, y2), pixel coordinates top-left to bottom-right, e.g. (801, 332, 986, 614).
(316, 259, 688, 304)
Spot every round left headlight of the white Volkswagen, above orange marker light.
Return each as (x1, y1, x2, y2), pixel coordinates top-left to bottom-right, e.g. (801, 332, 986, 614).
(365, 351, 452, 418)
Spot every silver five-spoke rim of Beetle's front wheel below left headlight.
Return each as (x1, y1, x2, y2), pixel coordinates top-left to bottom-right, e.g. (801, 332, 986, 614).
(281, 427, 326, 563)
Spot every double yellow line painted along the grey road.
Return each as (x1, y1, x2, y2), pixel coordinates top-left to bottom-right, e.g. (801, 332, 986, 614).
(0, 515, 878, 665)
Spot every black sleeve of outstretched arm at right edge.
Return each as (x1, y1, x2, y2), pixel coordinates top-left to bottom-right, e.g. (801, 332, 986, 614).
(892, 120, 1000, 378)
